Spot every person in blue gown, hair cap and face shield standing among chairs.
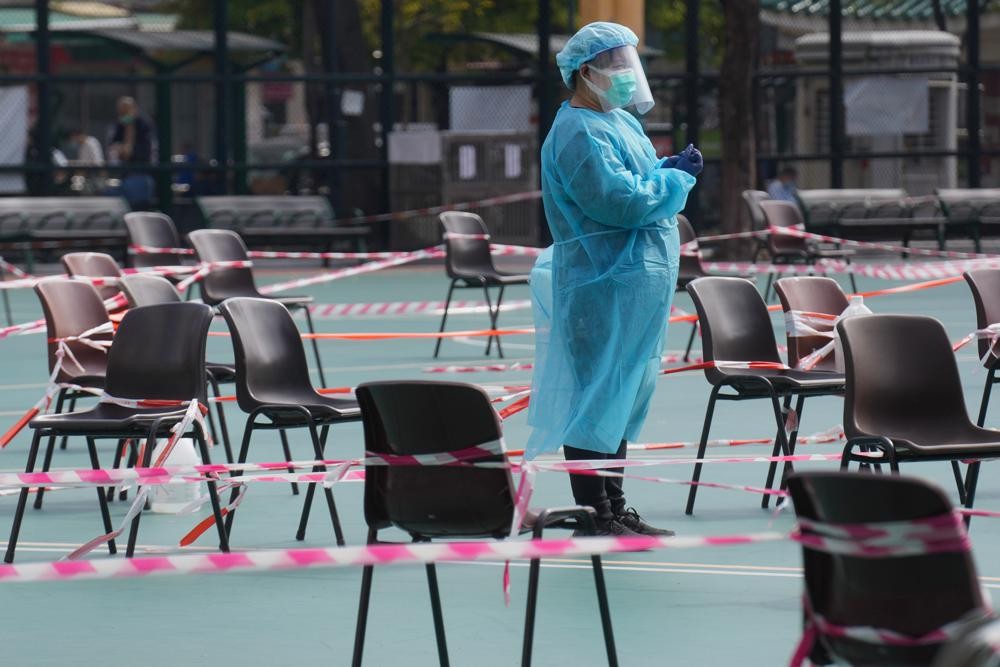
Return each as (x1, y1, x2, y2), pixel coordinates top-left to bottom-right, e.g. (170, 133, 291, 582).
(527, 22, 702, 535)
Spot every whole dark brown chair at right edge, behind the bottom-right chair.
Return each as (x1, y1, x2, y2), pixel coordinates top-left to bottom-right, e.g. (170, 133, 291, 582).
(837, 315, 1000, 507)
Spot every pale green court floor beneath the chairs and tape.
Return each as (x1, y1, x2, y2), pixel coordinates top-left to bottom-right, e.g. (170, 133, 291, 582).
(0, 253, 1000, 667)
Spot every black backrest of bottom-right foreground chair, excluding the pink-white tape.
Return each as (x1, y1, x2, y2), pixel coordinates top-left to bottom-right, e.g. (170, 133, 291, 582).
(788, 472, 983, 665)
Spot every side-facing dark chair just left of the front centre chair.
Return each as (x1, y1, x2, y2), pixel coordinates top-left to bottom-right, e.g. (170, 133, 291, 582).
(220, 297, 361, 545)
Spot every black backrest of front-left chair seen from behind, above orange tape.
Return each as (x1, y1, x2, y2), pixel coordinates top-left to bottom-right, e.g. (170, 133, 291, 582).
(105, 302, 212, 405)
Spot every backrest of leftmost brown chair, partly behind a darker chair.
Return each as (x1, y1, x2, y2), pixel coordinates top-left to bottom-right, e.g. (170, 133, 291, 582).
(35, 278, 112, 382)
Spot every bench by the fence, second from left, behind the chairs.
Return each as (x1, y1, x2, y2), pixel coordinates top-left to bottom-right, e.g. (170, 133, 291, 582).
(196, 195, 371, 260)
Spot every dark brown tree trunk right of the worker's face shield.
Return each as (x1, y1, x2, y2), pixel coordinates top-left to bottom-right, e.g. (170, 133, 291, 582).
(719, 0, 760, 254)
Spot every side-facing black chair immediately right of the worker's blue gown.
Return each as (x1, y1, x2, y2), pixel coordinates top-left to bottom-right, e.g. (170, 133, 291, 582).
(684, 276, 844, 514)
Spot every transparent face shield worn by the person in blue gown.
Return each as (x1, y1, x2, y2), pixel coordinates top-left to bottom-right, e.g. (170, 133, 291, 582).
(577, 46, 653, 114)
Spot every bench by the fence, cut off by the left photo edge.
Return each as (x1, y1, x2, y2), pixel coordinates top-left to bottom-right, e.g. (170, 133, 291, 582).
(0, 197, 129, 270)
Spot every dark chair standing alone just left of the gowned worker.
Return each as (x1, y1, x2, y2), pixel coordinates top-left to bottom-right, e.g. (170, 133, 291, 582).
(434, 211, 528, 359)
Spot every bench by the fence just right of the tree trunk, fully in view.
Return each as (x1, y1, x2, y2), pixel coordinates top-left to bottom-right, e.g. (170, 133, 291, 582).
(798, 188, 945, 254)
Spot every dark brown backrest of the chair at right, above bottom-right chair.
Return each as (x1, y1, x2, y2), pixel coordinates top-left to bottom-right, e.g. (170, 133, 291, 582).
(837, 315, 971, 442)
